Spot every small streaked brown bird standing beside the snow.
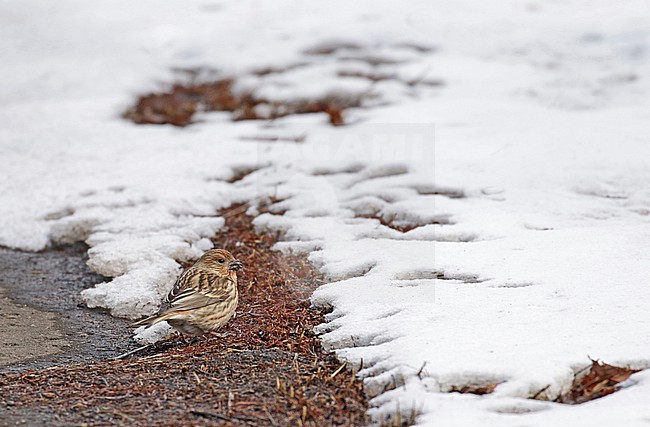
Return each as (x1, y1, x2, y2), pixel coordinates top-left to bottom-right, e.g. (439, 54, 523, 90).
(132, 249, 242, 336)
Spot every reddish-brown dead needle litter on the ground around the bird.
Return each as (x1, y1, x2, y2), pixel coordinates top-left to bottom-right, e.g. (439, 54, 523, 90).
(0, 205, 367, 426)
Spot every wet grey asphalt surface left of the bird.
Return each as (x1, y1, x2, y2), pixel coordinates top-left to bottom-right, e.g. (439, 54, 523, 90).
(0, 244, 136, 372)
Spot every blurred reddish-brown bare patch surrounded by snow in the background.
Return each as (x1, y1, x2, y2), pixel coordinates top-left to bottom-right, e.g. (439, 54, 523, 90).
(123, 78, 362, 127)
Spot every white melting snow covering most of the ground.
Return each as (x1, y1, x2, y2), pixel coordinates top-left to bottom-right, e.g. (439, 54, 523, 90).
(0, 0, 650, 426)
